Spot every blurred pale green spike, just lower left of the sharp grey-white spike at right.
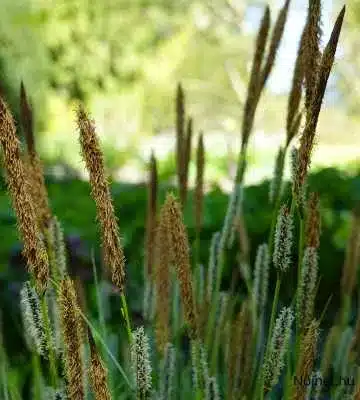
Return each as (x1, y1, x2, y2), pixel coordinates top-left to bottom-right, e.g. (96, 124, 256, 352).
(253, 243, 270, 314)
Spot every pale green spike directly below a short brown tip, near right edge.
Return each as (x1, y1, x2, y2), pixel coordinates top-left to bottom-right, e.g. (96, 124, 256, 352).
(296, 247, 318, 330)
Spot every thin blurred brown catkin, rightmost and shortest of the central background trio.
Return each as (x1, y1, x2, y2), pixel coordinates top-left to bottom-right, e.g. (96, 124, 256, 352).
(194, 133, 205, 235)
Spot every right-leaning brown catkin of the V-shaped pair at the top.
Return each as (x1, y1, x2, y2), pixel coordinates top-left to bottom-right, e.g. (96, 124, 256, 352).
(260, 0, 290, 88)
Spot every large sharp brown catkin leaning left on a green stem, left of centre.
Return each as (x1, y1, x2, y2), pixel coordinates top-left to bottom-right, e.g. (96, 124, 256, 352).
(77, 107, 125, 292)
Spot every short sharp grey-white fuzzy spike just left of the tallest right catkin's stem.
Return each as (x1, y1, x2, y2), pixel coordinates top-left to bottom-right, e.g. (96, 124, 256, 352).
(273, 206, 293, 272)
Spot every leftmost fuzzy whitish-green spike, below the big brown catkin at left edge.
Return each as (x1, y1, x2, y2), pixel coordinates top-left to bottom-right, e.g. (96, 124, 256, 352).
(20, 281, 47, 355)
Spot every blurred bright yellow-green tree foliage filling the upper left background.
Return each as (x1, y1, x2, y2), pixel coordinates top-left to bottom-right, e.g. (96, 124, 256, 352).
(0, 0, 263, 166)
